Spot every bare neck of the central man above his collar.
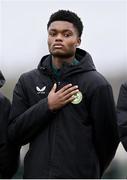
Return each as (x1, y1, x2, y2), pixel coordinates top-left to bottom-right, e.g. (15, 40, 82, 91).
(52, 56, 75, 69)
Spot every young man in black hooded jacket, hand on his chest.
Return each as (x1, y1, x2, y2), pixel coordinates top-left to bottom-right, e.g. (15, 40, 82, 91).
(9, 10, 118, 179)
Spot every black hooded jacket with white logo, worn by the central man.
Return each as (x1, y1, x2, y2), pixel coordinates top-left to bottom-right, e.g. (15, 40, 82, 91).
(9, 49, 118, 178)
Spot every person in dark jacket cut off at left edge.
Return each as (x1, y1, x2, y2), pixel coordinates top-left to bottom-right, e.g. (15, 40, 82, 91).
(0, 71, 19, 179)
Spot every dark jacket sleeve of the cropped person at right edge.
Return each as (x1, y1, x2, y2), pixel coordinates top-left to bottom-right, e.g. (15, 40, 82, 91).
(117, 84, 127, 151)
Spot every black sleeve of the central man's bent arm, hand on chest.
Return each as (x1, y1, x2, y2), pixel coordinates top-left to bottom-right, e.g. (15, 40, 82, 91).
(8, 76, 54, 145)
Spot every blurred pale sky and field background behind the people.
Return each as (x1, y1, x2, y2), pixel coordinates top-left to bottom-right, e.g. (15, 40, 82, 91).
(0, 0, 127, 179)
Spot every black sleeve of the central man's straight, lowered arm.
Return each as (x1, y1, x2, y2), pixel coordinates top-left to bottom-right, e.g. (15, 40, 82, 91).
(91, 85, 119, 175)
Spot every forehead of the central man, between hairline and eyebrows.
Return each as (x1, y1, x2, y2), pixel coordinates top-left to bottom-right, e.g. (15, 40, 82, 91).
(48, 21, 76, 31)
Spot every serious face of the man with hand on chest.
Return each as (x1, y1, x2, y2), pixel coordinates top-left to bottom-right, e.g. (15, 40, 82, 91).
(48, 21, 81, 58)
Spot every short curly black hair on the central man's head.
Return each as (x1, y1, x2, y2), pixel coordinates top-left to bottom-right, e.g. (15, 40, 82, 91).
(47, 10, 83, 37)
